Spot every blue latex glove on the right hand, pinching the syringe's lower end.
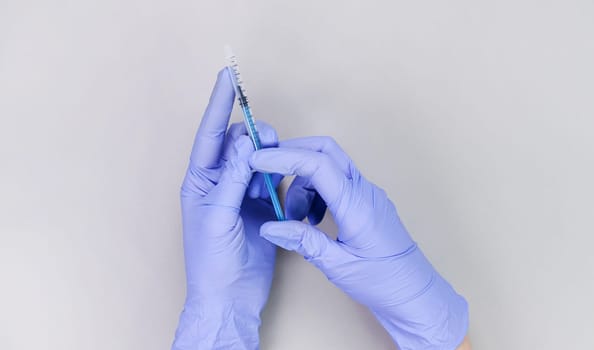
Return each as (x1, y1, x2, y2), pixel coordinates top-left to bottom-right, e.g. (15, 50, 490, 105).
(250, 137, 468, 350)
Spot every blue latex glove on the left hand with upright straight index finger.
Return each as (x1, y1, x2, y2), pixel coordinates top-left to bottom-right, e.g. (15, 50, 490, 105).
(172, 69, 280, 350)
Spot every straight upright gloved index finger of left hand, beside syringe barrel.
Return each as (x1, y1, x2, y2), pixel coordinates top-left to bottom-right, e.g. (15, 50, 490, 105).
(190, 68, 235, 168)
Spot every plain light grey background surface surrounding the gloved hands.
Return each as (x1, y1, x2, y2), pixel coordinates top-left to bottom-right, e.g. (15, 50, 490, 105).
(0, 0, 594, 350)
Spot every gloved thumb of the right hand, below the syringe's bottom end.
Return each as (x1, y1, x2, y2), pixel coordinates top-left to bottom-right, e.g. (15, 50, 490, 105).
(260, 220, 344, 270)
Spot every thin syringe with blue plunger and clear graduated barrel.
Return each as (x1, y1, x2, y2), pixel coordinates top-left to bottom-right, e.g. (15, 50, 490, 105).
(225, 46, 285, 221)
